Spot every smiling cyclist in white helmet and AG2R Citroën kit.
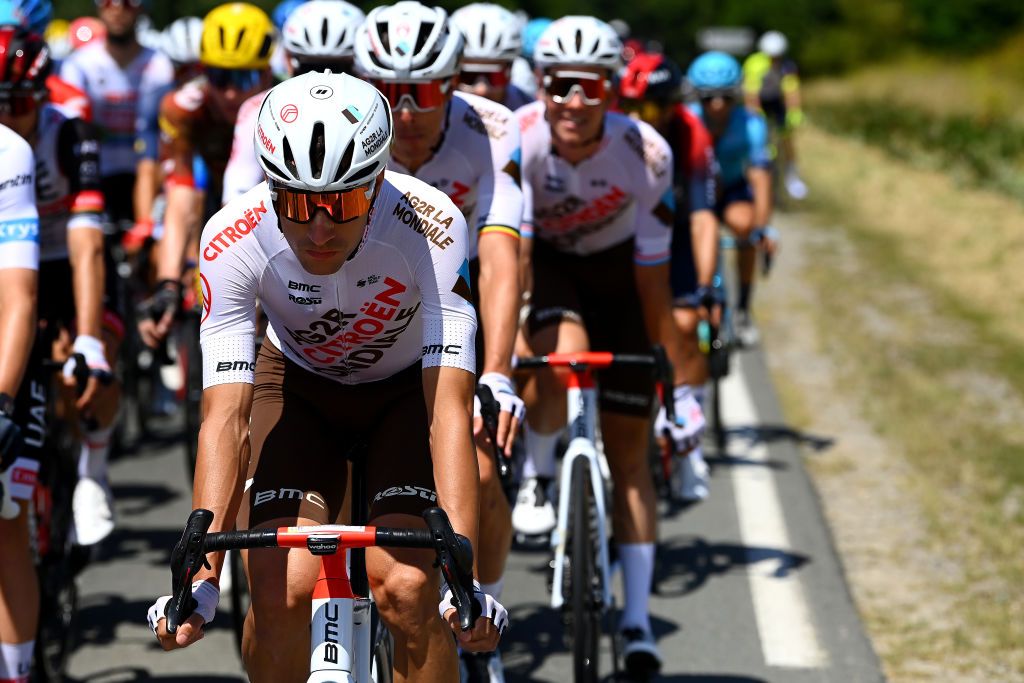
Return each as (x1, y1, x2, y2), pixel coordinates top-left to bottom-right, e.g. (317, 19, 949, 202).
(513, 16, 703, 680)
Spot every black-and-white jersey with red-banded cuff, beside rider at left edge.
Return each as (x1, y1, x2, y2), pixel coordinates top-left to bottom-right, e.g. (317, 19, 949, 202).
(35, 104, 103, 261)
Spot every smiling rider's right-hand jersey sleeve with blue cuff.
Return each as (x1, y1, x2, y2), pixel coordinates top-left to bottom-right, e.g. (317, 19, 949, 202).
(634, 123, 676, 265)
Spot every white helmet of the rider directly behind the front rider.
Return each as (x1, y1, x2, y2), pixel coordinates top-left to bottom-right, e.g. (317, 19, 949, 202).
(355, 0, 463, 81)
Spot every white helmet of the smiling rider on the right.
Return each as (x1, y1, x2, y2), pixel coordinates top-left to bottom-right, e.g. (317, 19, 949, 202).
(534, 15, 623, 72)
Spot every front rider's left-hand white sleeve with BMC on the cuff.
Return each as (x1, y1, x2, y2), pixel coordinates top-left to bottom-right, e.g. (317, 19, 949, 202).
(199, 211, 259, 389)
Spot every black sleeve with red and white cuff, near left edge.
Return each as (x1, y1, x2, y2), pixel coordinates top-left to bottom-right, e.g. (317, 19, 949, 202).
(57, 119, 103, 230)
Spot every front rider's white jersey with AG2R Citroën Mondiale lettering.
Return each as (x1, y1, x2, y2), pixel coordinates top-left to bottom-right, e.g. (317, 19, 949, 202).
(200, 172, 476, 388)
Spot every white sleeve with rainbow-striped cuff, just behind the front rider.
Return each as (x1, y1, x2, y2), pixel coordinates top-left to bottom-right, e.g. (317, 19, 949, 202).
(476, 100, 522, 238)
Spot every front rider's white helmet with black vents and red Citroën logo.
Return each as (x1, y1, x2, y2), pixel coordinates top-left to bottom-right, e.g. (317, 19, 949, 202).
(253, 72, 391, 193)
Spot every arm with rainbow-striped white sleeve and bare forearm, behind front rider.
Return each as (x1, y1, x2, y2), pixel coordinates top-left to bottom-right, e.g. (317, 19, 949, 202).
(477, 108, 523, 377)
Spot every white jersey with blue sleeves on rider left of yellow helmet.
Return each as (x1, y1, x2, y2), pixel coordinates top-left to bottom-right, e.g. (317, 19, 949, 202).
(60, 41, 174, 177)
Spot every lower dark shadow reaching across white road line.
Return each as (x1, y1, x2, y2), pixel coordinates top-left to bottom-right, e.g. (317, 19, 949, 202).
(654, 537, 811, 597)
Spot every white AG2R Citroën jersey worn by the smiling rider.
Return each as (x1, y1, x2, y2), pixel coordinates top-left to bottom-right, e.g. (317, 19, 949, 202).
(516, 101, 675, 265)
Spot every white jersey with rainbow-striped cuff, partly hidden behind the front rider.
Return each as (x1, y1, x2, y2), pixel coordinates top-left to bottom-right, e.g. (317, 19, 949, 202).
(388, 92, 523, 260)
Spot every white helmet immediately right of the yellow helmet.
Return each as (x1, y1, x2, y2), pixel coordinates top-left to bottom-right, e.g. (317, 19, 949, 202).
(282, 0, 366, 66)
